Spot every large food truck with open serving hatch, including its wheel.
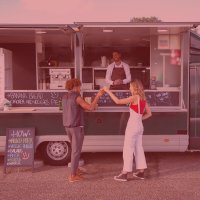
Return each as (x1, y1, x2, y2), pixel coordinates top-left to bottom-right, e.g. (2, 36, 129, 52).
(0, 22, 200, 165)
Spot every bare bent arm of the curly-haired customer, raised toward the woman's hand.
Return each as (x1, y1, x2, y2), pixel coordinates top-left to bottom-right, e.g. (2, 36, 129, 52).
(76, 90, 104, 111)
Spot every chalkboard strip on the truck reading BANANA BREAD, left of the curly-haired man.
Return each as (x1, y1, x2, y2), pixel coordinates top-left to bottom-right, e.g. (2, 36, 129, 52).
(5, 91, 67, 107)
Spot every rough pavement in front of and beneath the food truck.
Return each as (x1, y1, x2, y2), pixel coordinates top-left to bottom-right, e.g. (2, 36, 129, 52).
(0, 152, 200, 200)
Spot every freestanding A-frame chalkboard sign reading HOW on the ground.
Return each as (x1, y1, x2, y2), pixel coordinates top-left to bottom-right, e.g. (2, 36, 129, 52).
(4, 127, 35, 173)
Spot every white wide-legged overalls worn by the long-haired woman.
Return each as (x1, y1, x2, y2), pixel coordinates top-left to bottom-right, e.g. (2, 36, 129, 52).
(123, 96, 147, 172)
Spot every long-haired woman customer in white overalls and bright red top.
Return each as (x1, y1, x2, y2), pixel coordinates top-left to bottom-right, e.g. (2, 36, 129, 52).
(103, 79, 152, 181)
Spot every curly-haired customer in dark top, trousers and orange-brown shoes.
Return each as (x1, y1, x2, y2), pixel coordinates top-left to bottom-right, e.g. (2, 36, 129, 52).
(62, 79, 104, 182)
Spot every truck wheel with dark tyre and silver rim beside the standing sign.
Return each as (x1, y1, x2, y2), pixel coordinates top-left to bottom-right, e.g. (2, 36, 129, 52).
(40, 141, 71, 166)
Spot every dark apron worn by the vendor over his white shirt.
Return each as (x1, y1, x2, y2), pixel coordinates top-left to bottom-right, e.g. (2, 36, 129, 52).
(110, 65, 128, 90)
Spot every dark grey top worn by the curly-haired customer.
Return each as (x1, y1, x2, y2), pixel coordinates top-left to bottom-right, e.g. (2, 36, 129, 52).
(62, 90, 84, 128)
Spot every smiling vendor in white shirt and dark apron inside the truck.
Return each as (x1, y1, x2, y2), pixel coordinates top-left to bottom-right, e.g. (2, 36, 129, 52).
(106, 50, 131, 90)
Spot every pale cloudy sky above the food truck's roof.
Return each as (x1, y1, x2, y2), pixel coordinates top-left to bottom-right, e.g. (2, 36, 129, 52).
(0, 0, 200, 24)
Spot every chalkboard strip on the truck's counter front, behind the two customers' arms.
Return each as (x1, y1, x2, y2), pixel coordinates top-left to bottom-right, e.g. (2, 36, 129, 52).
(83, 91, 179, 107)
